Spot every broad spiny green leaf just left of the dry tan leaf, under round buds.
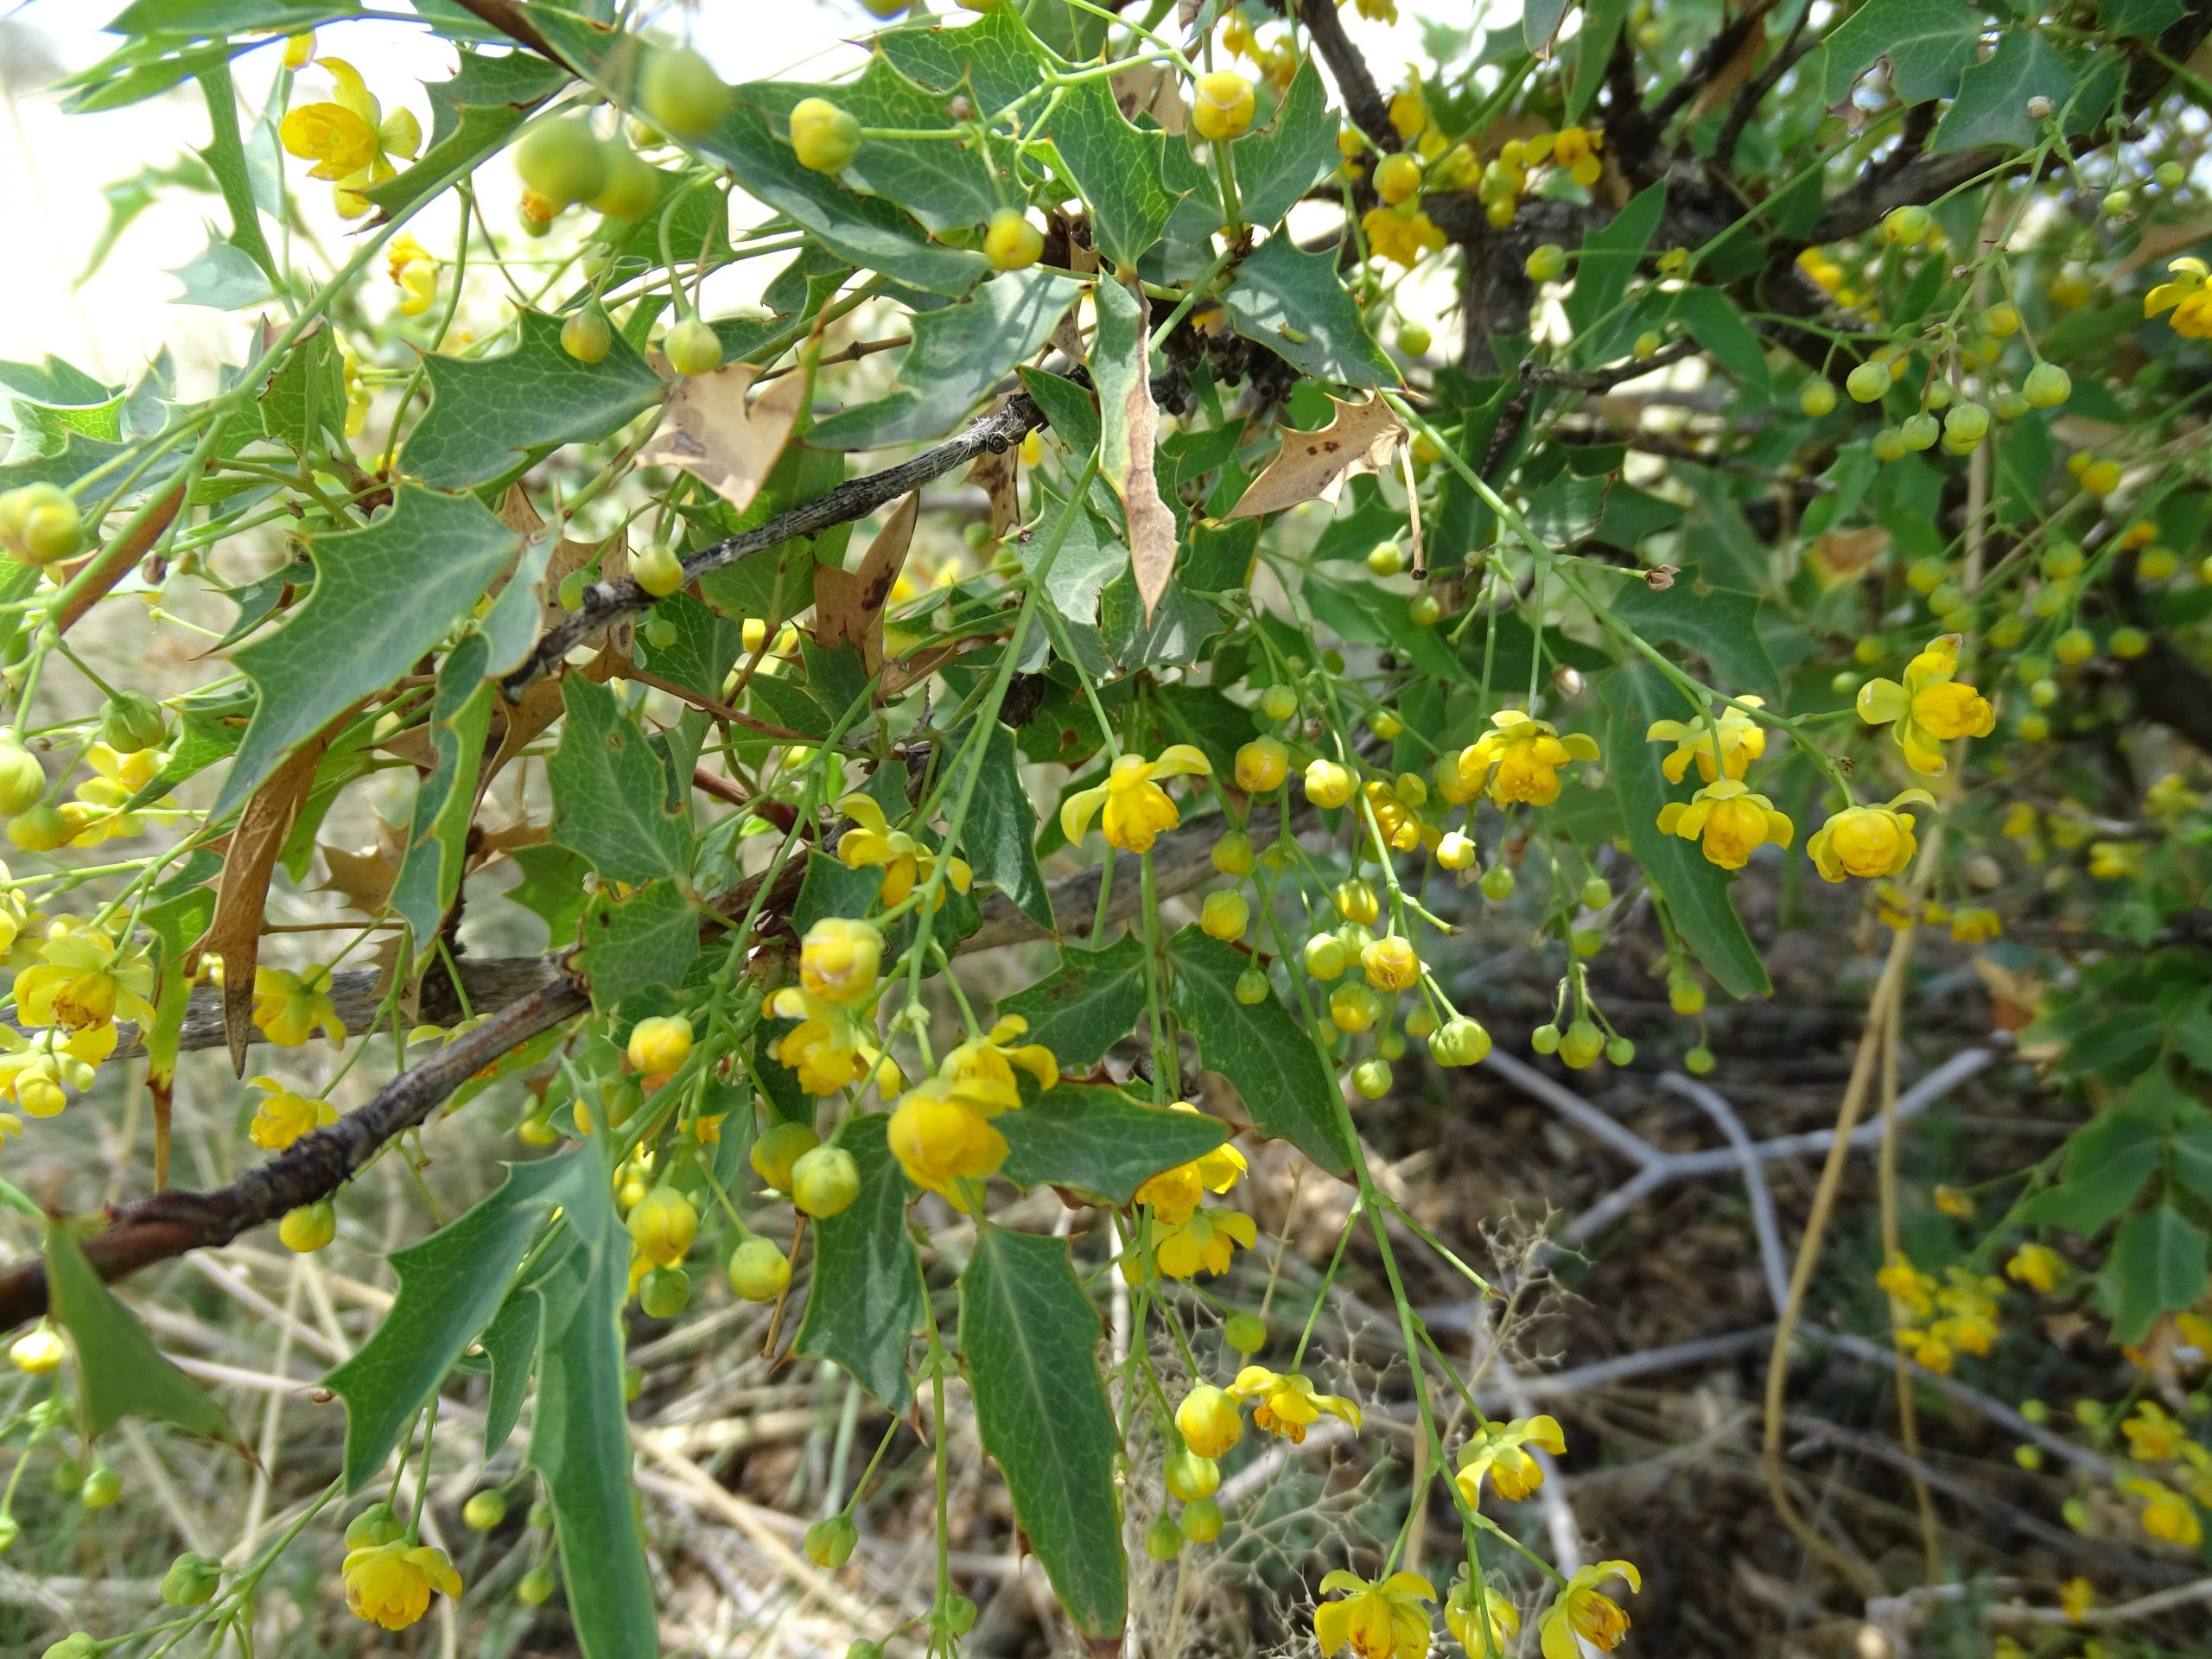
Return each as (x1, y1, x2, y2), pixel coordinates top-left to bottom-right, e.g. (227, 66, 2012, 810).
(400, 312, 661, 489)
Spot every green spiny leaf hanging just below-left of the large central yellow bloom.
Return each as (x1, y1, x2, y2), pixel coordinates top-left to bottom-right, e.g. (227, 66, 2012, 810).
(791, 1113, 925, 1411)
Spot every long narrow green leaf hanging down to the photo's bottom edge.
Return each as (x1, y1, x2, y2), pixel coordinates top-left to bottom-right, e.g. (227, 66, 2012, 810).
(529, 1148, 661, 1659)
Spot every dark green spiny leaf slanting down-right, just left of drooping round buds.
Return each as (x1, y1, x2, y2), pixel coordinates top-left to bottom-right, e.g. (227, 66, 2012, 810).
(1168, 925, 1351, 1174)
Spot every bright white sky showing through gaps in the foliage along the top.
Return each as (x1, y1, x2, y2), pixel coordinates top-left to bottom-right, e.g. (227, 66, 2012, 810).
(0, 0, 1460, 391)
